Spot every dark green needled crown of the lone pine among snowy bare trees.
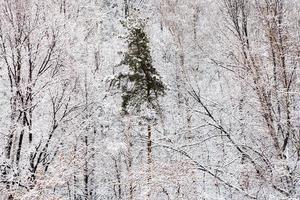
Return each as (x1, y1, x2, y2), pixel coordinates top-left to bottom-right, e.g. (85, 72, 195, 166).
(118, 21, 165, 113)
